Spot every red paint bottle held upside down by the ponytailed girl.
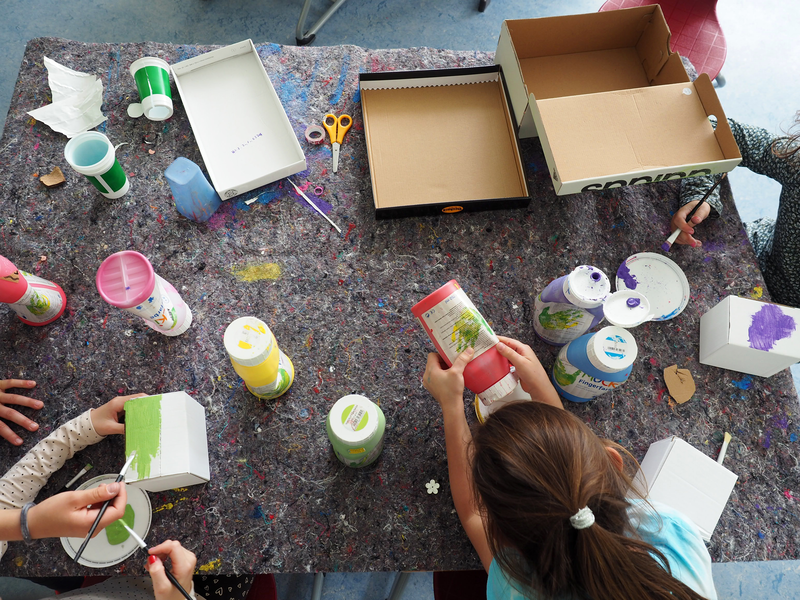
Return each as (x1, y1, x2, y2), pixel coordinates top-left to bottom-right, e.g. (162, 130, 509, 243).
(411, 279, 519, 406)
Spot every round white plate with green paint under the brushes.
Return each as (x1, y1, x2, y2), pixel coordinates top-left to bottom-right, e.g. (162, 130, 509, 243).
(61, 473, 153, 569)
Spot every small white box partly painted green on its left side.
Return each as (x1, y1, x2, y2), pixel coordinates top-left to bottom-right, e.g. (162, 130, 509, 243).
(125, 392, 211, 492)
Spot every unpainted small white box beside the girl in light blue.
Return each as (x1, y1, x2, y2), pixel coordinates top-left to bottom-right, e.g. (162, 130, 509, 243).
(634, 436, 739, 541)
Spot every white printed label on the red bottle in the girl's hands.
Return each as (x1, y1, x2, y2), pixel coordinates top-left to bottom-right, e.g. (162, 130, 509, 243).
(420, 288, 500, 364)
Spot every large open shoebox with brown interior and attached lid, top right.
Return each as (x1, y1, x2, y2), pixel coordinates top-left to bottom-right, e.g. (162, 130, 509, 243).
(495, 4, 741, 195)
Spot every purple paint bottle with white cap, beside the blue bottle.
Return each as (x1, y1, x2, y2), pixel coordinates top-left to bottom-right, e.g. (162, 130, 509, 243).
(533, 265, 611, 346)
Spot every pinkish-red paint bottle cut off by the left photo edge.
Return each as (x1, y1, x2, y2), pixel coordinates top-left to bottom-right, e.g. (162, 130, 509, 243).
(0, 256, 67, 325)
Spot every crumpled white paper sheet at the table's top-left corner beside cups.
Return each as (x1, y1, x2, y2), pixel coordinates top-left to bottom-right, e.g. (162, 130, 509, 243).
(28, 56, 106, 138)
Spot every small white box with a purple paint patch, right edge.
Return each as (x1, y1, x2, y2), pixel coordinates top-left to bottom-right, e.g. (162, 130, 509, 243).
(700, 296, 800, 377)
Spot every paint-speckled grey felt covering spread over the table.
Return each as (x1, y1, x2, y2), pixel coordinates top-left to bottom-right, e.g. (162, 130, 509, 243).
(0, 38, 800, 576)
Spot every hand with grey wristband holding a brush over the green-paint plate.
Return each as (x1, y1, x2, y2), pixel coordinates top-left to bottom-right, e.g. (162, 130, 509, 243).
(28, 483, 128, 539)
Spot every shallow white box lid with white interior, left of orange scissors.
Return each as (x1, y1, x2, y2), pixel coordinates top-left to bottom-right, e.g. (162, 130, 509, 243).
(172, 40, 306, 200)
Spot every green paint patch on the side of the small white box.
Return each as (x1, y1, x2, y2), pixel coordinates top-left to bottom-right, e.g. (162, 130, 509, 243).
(125, 394, 161, 480)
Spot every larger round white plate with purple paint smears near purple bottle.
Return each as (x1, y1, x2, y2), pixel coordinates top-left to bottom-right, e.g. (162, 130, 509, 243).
(616, 252, 689, 321)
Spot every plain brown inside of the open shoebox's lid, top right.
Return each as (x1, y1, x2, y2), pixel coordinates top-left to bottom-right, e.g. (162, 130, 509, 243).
(532, 77, 741, 181)
